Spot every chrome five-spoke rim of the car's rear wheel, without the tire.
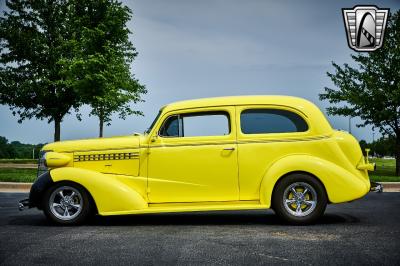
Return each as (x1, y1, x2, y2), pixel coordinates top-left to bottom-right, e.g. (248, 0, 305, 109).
(283, 182, 317, 217)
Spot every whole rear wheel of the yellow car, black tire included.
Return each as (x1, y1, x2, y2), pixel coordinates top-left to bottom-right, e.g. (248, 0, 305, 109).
(272, 173, 328, 225)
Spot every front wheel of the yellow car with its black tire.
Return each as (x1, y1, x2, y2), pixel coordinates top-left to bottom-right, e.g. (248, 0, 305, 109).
(42, 181, 93, 225)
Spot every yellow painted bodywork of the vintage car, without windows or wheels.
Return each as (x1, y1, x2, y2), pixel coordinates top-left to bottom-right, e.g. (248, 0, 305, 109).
(43, 96, 373, 215)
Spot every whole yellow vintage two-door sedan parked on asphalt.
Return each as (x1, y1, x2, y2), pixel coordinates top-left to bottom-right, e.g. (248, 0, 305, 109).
(19, 96, 382, 224)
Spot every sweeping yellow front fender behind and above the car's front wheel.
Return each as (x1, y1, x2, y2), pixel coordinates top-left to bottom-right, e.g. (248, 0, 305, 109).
(50, 167, 148, 215)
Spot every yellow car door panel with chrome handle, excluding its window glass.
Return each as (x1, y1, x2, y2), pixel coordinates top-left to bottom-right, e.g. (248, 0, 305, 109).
(148, 107, 239, 202)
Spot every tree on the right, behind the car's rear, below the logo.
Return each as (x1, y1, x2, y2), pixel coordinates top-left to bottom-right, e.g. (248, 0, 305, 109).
(320, 11, 400, 176)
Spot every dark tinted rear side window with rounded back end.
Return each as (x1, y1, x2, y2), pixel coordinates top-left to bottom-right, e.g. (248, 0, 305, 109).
(240, 109, 308, 134)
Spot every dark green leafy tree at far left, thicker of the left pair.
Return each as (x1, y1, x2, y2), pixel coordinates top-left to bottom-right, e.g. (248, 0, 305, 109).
(0, 0, 80, 141)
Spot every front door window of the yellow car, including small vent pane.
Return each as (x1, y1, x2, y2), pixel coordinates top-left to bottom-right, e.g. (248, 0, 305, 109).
(159, 112, 230, 137)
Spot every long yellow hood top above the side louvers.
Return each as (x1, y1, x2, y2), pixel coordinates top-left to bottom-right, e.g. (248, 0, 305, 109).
(42, 136, 140, 152)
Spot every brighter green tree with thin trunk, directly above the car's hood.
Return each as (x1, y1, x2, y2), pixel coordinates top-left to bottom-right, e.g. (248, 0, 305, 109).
(66, 0, 147, 137)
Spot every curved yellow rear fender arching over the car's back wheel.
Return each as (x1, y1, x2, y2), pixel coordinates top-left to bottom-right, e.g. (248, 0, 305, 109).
(260, 154, 370, 207)
